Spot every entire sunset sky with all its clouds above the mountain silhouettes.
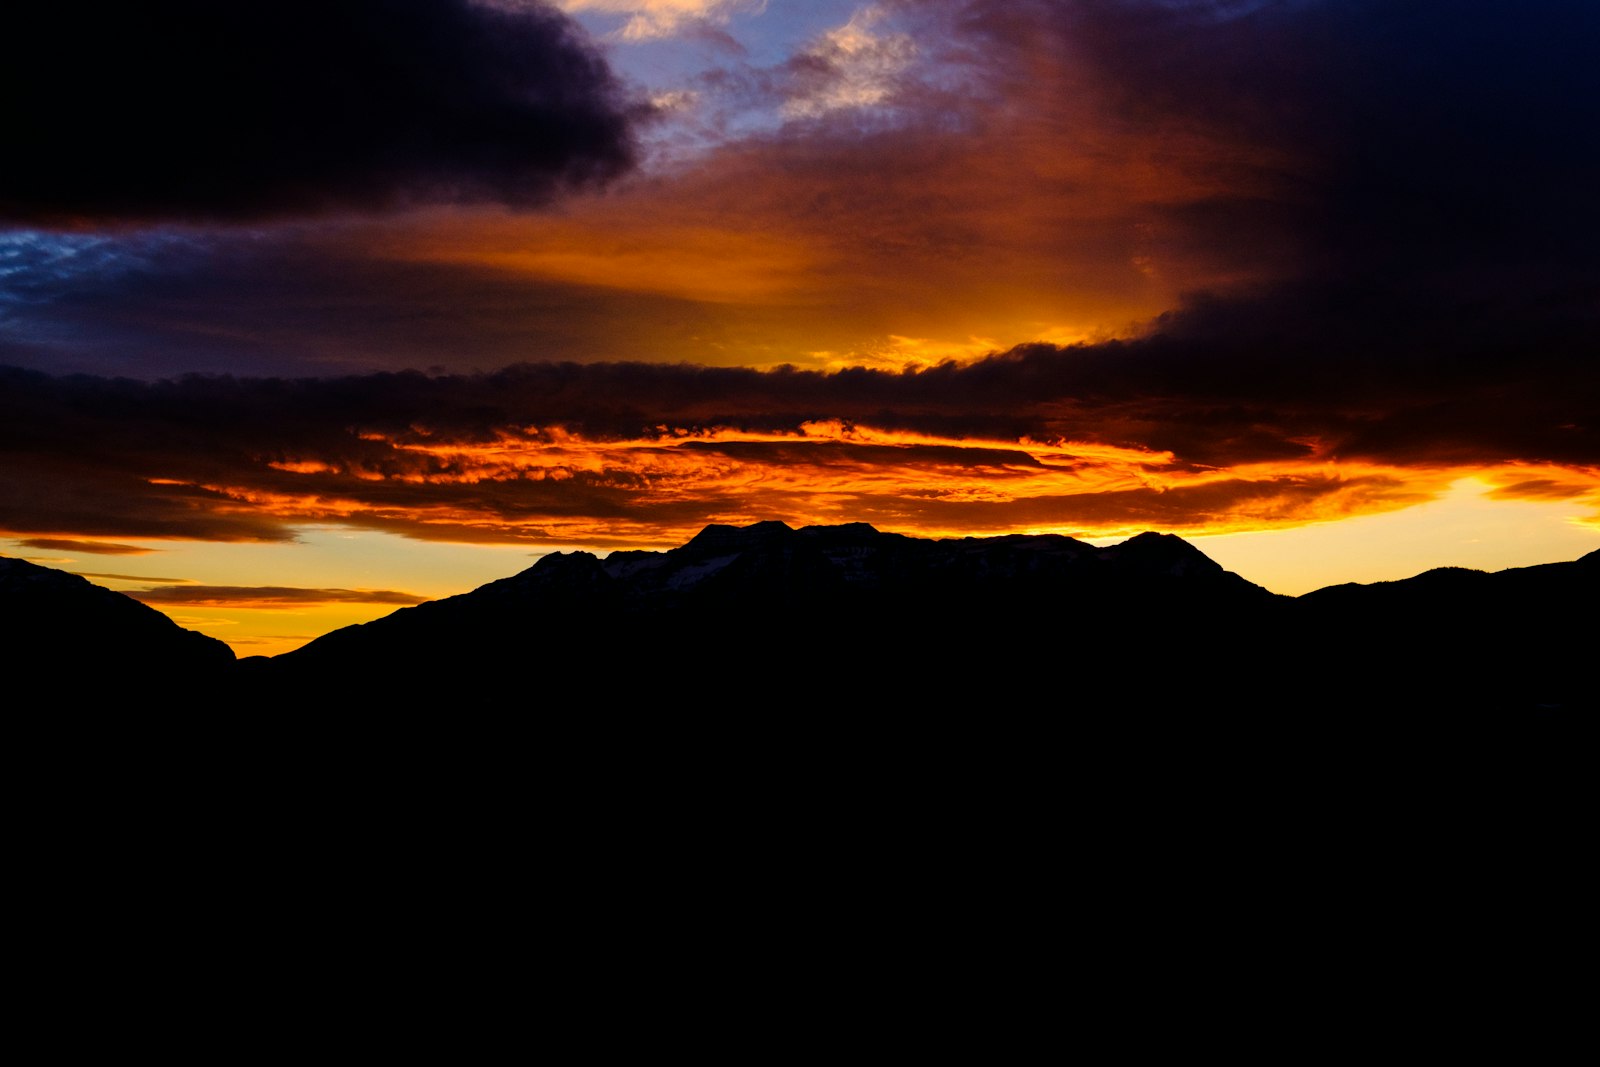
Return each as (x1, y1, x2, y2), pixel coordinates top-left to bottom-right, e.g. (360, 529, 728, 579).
(0, 0, 1600, 654)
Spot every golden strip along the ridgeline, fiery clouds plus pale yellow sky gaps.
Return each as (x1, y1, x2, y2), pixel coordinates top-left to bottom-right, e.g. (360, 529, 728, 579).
(16, 447, 1600, 656)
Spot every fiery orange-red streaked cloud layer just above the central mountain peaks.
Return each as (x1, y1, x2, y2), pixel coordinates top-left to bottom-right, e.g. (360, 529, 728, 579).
(147, 419, 1600, 547)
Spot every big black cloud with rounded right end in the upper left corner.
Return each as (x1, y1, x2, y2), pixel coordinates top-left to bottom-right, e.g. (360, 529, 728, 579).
(0, 0, 632, 224)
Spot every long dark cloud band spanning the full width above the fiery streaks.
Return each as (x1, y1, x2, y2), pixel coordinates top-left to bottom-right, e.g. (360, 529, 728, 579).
(0, 342, 1600, 476)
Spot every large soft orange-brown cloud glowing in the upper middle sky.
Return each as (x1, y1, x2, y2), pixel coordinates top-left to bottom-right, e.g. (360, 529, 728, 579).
(356, 4, 1294, 374)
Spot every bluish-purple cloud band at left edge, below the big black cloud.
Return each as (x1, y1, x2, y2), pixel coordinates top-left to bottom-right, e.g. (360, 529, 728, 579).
(0, 226, 736, 379)
